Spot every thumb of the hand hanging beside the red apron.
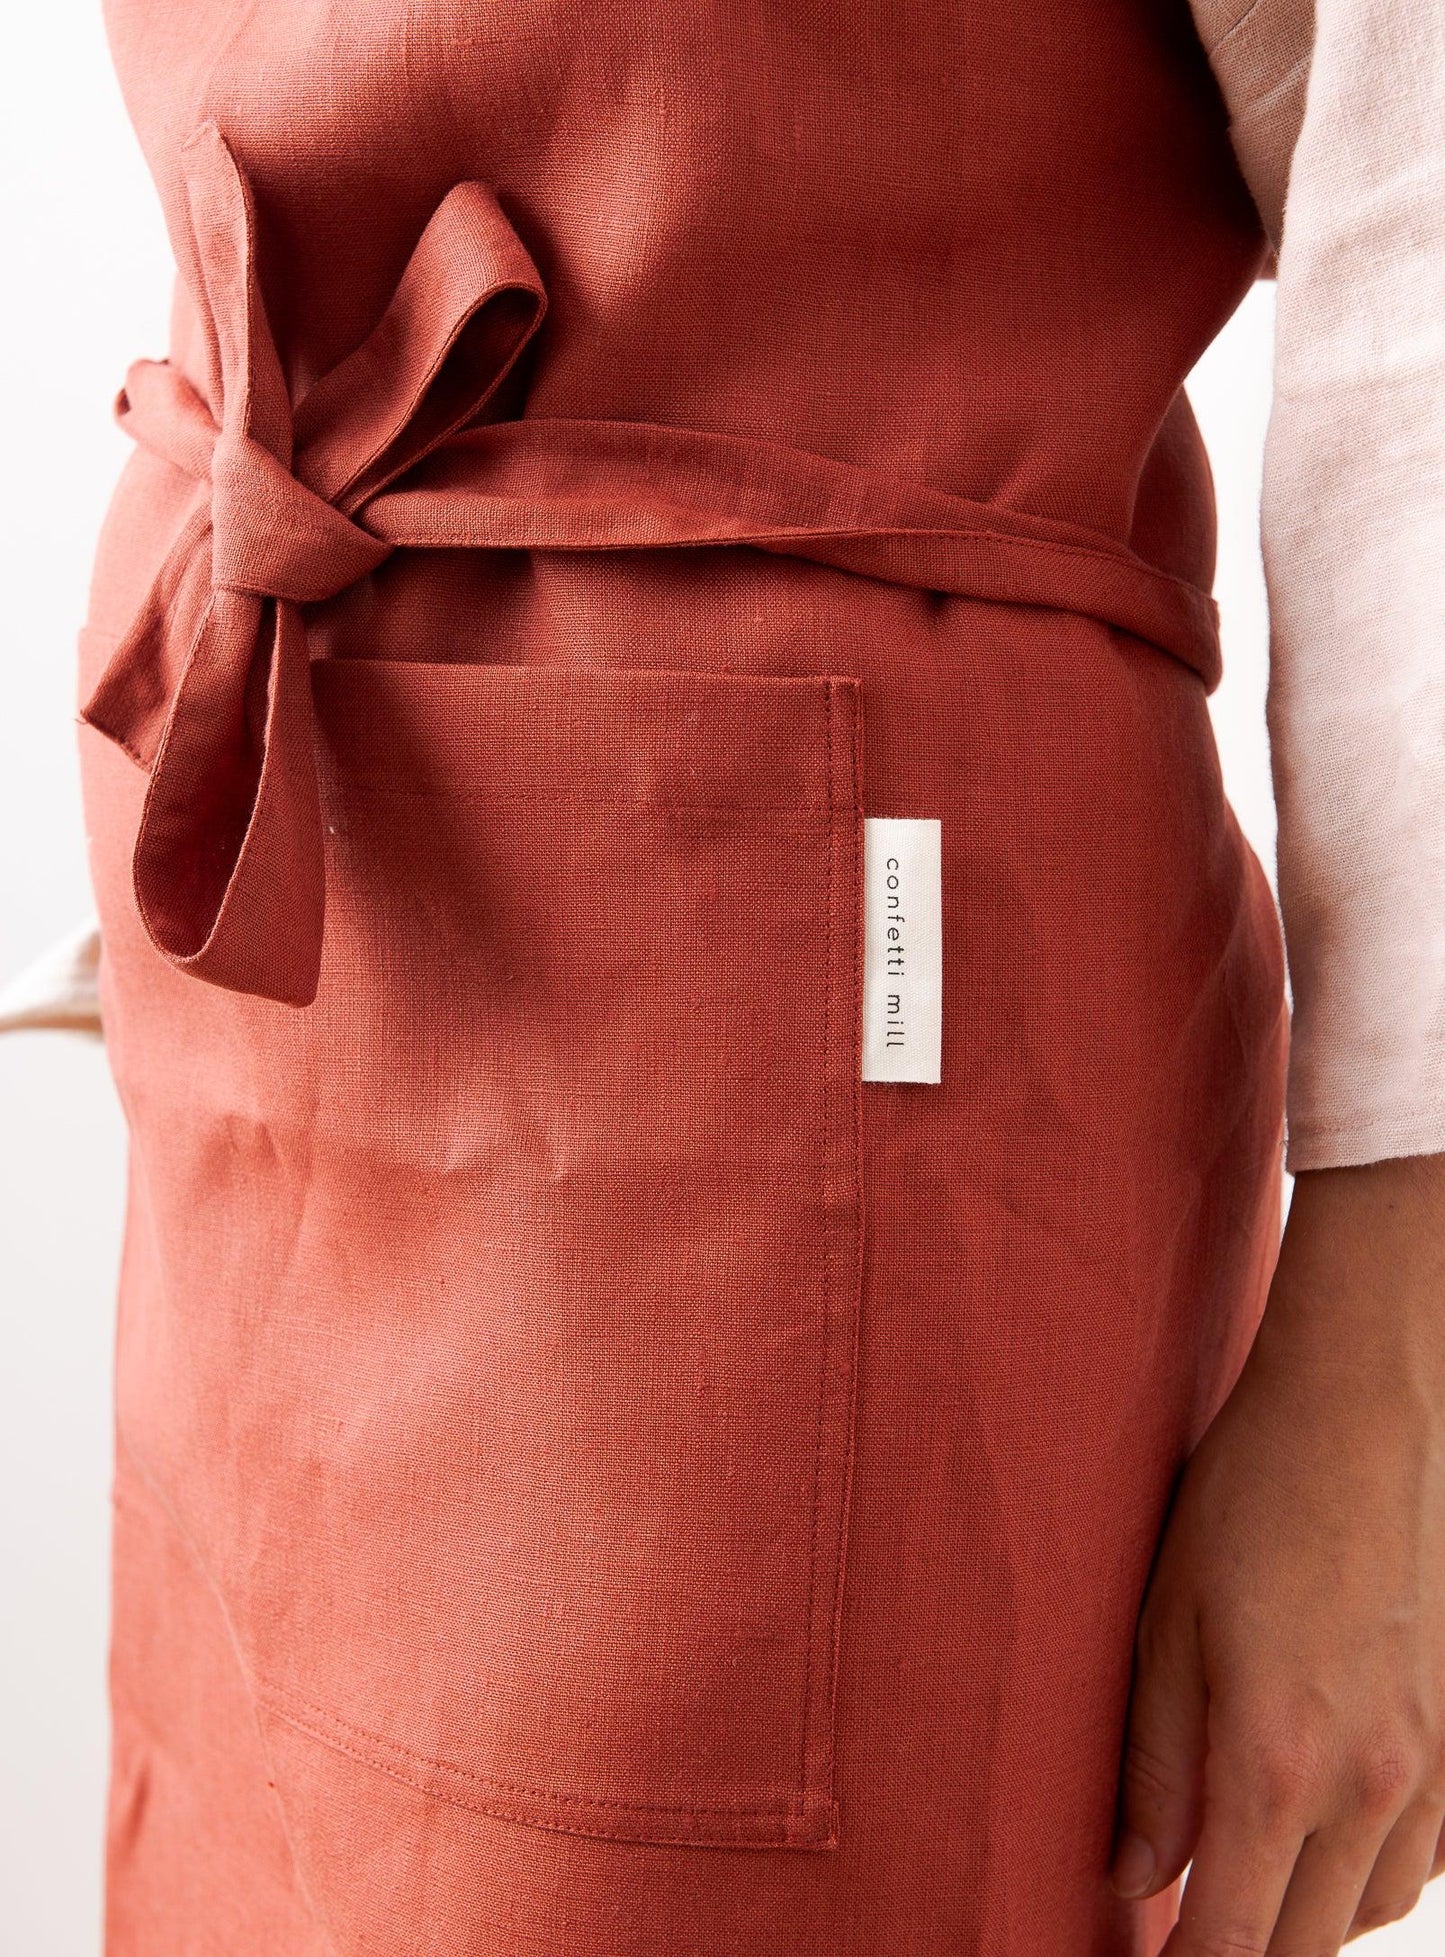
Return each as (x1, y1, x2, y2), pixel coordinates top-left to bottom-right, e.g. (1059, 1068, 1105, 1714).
(1110, 1597, 1208, 1896)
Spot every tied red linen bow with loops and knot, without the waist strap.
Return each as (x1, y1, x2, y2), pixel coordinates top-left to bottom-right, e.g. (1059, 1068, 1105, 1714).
(82, 123, 546, 1006)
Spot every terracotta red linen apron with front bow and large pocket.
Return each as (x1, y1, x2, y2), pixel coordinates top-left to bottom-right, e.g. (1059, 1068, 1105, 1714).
(80, 0, 1286, 1957)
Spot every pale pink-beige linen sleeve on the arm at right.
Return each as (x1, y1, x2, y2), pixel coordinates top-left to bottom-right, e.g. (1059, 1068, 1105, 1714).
(1196, 0, 1445, 1170)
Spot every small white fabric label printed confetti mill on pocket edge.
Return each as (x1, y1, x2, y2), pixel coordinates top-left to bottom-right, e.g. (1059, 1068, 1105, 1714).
(863, 816, 944, 1080)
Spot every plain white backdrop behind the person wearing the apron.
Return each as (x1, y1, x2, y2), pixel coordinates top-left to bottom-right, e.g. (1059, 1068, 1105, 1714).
(0, 0, 1445, 1957)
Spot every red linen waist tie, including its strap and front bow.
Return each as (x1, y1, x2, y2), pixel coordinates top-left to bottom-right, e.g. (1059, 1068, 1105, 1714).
(82, 123, 1220, 1006)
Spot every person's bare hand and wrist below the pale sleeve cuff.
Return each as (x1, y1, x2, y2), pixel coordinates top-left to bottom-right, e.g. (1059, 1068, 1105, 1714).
(1112, 1157, 1445, 1957)
